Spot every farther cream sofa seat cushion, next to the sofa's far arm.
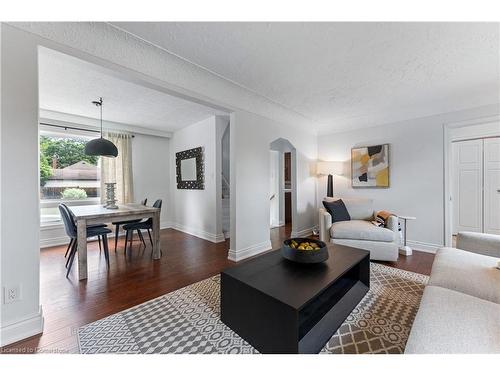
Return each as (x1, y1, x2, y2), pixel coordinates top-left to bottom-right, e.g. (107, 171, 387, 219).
(429, 247, 500, 303)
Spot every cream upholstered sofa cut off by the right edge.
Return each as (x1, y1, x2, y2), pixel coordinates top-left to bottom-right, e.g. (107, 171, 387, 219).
(405, 232, 500, 354)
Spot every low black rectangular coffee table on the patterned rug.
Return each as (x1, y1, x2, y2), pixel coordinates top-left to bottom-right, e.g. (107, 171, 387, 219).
(221, 244, 370, 353)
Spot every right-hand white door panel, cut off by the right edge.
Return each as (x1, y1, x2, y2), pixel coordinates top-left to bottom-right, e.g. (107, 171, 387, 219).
(484, 138, 500, 234)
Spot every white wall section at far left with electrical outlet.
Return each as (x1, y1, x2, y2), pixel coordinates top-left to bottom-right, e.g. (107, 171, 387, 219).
(0, 25, 43, 346)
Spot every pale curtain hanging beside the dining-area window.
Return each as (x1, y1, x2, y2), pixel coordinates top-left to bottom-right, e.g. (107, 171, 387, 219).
(101, 132, 134, 204)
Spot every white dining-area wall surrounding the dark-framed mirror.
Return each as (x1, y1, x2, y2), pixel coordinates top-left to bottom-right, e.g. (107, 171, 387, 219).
(170, 116, 224, 242)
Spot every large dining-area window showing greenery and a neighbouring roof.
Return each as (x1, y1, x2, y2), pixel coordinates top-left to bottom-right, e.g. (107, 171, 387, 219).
(40, 128, 100, 224)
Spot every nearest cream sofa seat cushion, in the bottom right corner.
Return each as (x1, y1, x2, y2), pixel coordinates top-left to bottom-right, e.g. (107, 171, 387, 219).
(405, 286, 500, 354)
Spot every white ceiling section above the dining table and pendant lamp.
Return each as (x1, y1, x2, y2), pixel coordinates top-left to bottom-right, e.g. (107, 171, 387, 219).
(39, 48, 223, 132)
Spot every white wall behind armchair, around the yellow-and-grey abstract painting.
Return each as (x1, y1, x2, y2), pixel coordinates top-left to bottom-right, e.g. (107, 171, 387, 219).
(318, 105, 499, 251)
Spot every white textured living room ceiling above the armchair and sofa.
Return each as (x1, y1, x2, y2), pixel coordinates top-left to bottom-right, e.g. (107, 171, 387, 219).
(112, 22, 500, 133)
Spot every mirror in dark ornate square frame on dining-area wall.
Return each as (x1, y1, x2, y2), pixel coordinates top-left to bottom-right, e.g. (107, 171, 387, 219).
(175, 147, 205, 190)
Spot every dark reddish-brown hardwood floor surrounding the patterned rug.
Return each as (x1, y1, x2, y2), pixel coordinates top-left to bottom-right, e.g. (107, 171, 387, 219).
(1, 226, 434, 353)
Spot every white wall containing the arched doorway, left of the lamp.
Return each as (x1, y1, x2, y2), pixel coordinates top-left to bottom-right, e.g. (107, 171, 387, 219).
(229, 111, 317, 260)
